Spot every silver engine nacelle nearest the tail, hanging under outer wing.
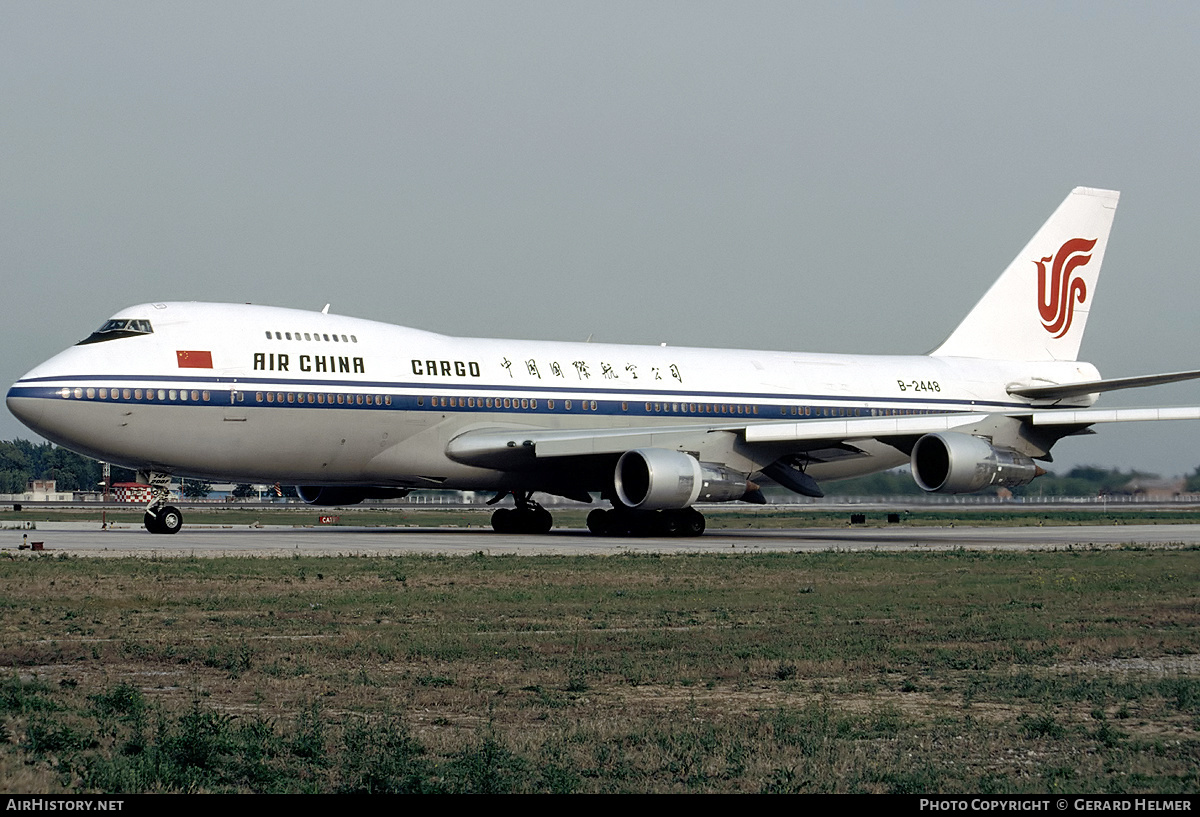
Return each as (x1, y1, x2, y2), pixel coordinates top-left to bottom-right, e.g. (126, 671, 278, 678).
(912, 431, 1045, 493)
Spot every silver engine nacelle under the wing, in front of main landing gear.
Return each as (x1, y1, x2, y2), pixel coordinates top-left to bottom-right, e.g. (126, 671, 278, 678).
(613, 449, 751, 511)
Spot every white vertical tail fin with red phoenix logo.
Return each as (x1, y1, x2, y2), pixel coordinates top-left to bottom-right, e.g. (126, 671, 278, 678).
(930, 187, 1120, 360)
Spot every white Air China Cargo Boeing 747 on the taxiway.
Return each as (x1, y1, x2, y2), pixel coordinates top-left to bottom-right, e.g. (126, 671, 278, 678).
(7, 187, 1200, 535)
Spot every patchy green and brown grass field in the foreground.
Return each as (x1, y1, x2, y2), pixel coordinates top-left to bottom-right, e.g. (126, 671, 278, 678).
(0, 549, 1200, 793)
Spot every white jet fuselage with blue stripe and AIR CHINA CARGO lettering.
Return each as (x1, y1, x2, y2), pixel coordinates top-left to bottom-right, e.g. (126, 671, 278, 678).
(7, 302, 1098, 488)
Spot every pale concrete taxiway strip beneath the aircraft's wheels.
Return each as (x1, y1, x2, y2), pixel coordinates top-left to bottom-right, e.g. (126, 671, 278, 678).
(9, 523, 1200, 558)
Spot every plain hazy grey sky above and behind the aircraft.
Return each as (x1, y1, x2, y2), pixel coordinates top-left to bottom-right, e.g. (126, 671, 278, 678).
(0, 0, 1200, 474)
